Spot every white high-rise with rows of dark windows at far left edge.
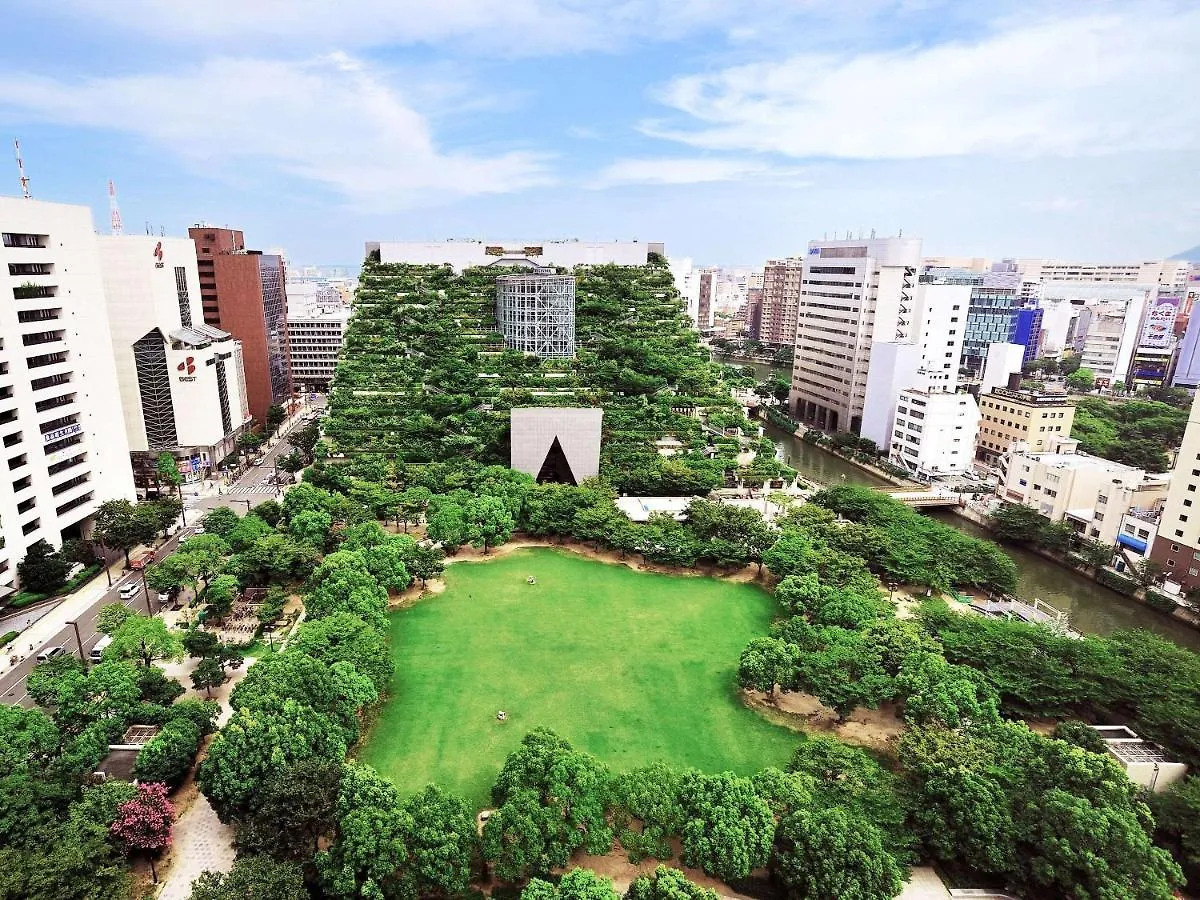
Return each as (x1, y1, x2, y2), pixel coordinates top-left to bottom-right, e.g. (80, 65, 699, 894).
(0, 197, 134, 587)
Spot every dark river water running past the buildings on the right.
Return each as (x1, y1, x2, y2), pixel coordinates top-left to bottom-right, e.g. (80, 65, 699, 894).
(730, 360, 1200, 650)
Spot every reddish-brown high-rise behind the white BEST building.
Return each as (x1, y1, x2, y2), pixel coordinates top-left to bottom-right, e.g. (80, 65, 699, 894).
(187, 224, 292, 422)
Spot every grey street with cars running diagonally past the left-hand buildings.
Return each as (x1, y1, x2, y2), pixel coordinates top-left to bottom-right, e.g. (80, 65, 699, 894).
(0, 406, 319, 707)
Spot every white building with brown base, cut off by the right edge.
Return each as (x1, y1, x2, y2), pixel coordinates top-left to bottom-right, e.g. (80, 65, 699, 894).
(1150, 394, 1200, 592)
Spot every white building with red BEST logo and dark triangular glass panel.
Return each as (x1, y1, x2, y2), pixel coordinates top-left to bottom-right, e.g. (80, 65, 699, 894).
(95, 235, 251, 496)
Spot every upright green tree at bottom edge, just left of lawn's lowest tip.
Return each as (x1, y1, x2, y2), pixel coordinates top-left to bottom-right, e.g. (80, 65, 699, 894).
(404, 785, 479, 896)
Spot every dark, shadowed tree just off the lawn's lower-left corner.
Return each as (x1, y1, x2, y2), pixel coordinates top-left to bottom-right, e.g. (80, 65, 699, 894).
(238, 760, 342, 863)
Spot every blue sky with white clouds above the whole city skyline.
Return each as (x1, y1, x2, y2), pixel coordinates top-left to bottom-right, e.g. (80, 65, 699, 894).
(0, 0, 1200, 265)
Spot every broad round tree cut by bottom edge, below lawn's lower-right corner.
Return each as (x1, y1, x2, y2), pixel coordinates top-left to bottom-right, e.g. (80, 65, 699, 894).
(773, 808, 904, 900)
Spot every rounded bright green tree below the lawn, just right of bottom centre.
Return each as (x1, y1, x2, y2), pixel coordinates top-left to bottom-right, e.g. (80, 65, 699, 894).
(679, 772, 775, 882)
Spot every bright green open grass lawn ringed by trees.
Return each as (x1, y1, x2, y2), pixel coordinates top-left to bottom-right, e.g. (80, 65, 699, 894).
(360, 550, 799, 806)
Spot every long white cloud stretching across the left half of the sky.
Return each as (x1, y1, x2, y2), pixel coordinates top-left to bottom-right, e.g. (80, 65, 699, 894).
(0, 53, 548, 212)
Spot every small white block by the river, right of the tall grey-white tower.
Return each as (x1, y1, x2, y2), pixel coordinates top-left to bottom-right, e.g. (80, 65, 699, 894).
(889, 389, 979, 481)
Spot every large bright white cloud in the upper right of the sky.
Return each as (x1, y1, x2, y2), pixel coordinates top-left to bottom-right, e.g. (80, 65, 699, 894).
(642, 2, 1200, 160)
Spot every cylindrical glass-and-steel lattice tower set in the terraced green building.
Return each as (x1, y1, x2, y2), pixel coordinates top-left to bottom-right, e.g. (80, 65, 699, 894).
(496, 271, 575, 359)
